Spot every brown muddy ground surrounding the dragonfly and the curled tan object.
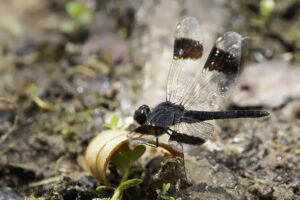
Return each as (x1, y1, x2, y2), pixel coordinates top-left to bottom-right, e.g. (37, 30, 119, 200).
(0, 0, 300, 200)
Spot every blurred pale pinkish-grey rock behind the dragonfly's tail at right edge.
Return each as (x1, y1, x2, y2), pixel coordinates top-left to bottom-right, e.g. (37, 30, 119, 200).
(231, 61, 300, 108)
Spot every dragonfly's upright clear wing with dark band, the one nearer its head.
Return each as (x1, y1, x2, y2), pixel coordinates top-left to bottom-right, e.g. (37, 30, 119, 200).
(167, 17, 203, 104)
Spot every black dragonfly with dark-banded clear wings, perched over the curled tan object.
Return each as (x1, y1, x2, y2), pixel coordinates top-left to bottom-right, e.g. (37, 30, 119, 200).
(129, 17, 269, 151)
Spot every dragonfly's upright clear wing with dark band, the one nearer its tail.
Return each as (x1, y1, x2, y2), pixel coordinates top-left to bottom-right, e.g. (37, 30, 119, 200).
(182, 32, 242, 111)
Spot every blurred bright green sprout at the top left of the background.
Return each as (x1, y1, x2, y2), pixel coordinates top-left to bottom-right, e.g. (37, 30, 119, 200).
(60, 1, 92, 33)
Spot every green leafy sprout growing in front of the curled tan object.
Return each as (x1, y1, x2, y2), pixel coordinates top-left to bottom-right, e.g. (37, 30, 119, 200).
(96, 144, 146, 200)
